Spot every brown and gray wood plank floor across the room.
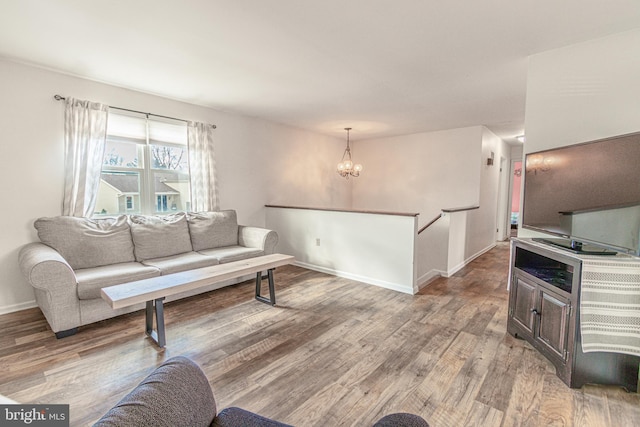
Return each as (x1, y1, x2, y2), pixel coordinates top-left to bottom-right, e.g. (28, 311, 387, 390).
(0, 243, 640, 427)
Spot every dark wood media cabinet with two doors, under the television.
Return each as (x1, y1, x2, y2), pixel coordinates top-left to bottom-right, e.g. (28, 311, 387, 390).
(507, 239, 640, 392)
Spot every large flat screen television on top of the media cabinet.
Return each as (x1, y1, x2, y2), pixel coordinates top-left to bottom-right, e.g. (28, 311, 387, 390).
(522, 132, 640, 256)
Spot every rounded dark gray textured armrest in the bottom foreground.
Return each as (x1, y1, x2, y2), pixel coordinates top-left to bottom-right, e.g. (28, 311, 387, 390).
(94, 356, 216, 427)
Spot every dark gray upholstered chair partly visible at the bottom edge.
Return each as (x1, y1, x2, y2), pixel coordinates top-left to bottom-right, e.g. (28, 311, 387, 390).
(94, 356, 429, 427)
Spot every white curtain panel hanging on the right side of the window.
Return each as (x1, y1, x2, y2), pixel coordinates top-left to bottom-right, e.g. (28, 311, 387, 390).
(187, 122, 219, 212)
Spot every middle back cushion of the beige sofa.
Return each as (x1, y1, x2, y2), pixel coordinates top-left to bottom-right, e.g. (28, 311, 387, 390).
(129, 212, 193, 261)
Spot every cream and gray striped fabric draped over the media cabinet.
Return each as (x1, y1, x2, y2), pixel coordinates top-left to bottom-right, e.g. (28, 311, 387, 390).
(580, 255, 640, 356)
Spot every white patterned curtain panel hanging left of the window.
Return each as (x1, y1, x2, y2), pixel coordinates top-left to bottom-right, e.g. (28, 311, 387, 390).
(62, 98, 108, 217)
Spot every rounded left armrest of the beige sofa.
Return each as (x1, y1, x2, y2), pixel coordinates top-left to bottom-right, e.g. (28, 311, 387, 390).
(18, 242, 80, 332)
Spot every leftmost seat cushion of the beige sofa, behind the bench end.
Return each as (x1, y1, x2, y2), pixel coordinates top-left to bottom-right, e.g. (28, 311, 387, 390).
(76, 262, 160, 300)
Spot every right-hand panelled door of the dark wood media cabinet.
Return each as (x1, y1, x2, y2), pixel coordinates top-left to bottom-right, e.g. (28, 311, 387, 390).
(535, 288, 571, 360)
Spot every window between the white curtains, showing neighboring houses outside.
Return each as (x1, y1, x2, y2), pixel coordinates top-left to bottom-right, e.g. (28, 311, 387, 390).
(95, 109, 190, 215)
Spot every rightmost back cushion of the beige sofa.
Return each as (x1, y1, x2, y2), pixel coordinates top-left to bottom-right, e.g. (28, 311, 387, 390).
(187, 210, 238, 251)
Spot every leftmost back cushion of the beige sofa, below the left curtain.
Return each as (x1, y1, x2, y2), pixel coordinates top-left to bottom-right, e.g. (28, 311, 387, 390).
(34, 215, 135, 270)
